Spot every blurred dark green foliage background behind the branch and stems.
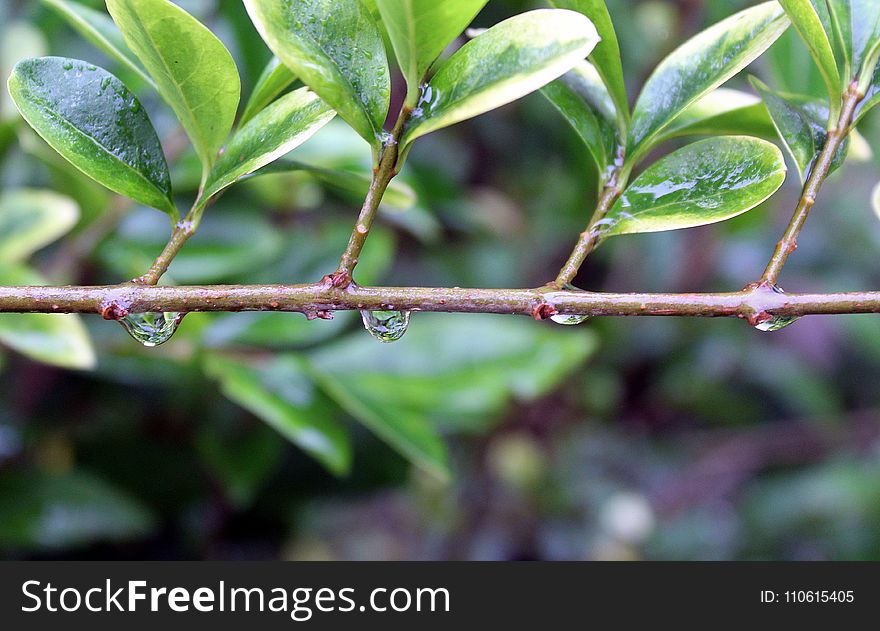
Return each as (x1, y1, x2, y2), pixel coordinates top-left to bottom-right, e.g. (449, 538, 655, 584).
(0, 0, 880, 560)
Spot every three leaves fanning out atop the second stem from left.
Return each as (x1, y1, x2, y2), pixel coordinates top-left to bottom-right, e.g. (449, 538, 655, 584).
(245, 0, 598, 155)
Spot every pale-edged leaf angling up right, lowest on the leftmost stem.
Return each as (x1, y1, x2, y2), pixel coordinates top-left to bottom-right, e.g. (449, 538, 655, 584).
(197, 88, 336, 205)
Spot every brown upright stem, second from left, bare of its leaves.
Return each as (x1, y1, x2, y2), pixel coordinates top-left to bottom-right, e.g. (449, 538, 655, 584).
(329, 105, 412, 289)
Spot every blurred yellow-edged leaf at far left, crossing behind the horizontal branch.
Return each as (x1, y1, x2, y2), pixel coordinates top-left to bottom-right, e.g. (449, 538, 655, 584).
(0, 265, 96, 370)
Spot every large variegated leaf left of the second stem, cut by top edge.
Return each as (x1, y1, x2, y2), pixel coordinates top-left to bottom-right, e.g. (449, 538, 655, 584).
(244, 0, 391, 150)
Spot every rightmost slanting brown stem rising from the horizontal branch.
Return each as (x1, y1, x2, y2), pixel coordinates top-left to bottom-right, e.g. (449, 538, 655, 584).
(761, 82, 864, 285)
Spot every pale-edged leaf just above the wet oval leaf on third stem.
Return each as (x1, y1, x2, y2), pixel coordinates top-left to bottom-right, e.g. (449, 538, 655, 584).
(657, 88, 777, 142)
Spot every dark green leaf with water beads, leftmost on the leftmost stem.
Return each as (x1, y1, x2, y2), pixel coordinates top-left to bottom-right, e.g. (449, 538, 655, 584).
(9, 57, 177, 219)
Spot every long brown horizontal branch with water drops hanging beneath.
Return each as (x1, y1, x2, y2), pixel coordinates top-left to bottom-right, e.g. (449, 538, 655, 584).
(0, 279, 880, 324)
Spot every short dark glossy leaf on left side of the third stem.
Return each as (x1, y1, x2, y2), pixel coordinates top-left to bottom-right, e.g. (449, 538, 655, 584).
(541, 61, 617, 175)
